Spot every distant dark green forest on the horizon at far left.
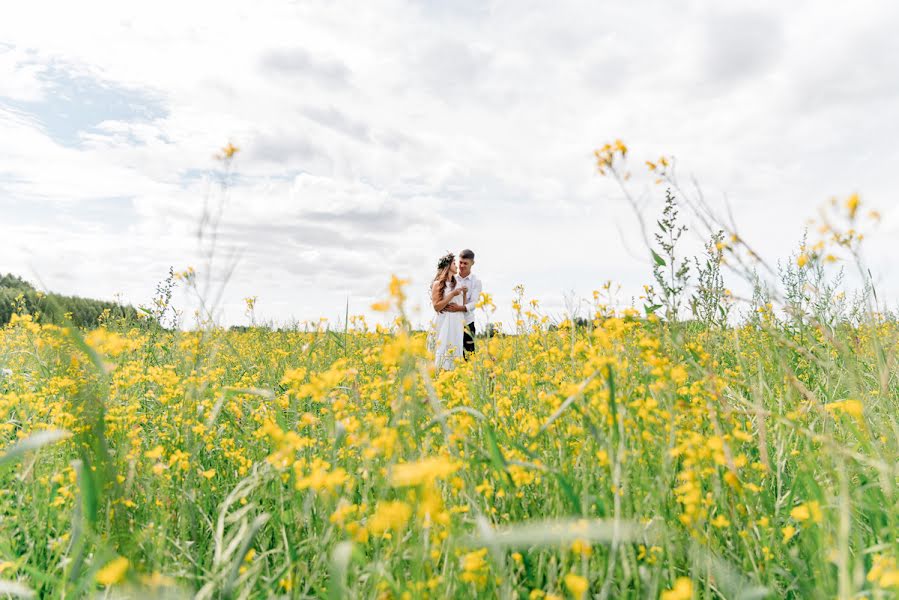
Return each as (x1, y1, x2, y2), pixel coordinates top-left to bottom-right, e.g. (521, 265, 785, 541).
(0, 274, 137, 327)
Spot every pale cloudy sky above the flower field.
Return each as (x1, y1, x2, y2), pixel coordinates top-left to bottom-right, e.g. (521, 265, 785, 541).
(0, 0, 899, 324)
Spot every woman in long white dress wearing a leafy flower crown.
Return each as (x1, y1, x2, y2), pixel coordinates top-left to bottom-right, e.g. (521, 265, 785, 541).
(431, 253, 468, 370)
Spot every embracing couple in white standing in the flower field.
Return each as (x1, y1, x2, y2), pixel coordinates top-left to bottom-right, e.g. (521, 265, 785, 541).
(431, 250, 481, 370)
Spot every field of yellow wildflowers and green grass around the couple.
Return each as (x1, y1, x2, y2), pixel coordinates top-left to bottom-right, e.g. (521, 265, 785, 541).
(0, 274, 899, 600)
